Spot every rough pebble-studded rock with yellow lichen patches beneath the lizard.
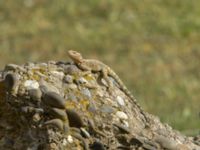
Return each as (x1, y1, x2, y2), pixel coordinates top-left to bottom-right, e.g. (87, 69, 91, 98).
(0, 61, 200, 150)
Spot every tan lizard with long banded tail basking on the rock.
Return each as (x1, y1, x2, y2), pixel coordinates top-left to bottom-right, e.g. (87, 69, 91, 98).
(68, 50, 148, 123)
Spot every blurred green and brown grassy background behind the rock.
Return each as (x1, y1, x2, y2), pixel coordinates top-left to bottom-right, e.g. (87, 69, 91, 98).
(0, 0, 200, 135)
